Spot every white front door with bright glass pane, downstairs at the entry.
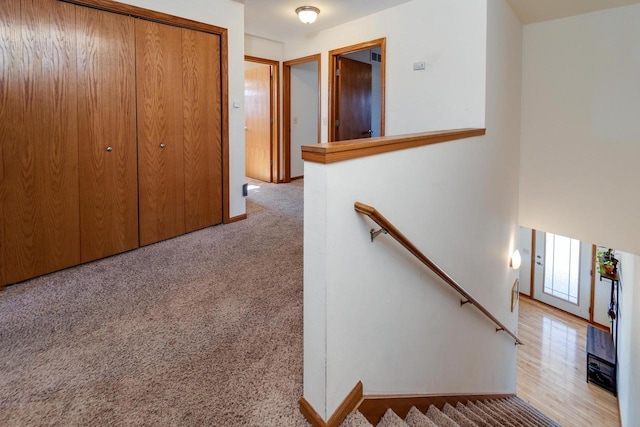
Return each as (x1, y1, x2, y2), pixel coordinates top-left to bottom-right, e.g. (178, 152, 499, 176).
(533, 230, 591, 320)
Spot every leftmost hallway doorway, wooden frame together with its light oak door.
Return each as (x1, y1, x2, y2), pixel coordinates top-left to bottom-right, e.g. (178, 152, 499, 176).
(244, 56, 280, 182)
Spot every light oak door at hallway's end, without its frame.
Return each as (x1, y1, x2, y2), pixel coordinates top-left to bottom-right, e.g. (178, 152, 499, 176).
(244, 66, 272, 182)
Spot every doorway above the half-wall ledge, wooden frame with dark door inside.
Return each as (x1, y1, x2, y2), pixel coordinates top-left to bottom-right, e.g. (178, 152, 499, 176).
(329, 38, 386, 142)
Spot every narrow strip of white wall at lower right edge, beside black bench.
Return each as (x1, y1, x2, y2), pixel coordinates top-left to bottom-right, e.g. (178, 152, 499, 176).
(618, 254, 640, 427)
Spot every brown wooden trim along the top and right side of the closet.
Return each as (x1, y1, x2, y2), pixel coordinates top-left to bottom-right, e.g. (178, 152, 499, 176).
(59, 0, 231, 224)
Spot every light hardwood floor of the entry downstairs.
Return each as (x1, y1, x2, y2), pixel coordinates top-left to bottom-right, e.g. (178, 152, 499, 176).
(517, 298, 620, 427)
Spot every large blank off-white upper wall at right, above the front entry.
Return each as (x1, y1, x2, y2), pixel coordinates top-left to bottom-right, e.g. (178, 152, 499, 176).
(520, 5, 640, 253)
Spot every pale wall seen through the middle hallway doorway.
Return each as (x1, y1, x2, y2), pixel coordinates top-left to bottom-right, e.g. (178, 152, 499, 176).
(291, 61, 318, 178)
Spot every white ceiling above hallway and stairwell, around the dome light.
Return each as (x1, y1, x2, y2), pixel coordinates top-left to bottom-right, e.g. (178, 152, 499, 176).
(239, 0, 640, 41)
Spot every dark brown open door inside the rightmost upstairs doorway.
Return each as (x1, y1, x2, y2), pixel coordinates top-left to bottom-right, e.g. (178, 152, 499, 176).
(334, 57, 371, 141)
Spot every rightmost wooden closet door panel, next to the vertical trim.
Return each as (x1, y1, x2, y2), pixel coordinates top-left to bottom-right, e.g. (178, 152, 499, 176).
(182, 29, 222, 232)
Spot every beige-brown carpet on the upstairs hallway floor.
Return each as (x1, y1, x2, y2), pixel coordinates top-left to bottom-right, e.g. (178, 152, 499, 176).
(0, 182, 307, 426)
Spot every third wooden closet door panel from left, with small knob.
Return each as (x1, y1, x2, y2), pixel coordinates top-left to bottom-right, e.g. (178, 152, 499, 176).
(136, 19, 185, 245)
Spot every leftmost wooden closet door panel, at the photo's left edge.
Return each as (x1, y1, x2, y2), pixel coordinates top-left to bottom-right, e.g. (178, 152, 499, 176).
(0, 0, 80, 285)
